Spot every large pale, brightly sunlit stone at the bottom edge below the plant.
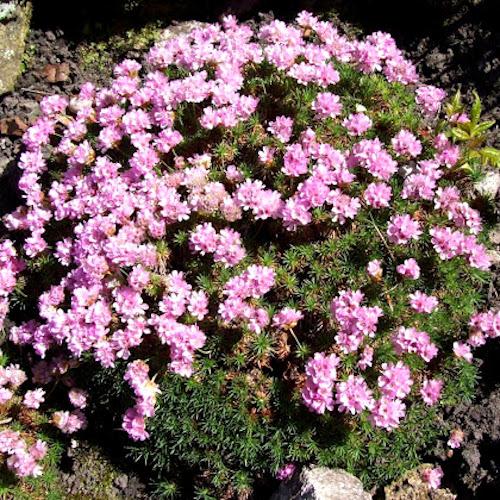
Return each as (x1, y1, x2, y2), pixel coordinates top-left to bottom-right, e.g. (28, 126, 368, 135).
(271, 466, 372, 500)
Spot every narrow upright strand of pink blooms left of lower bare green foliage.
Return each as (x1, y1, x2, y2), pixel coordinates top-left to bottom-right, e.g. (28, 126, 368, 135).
(122, 360, 160, 441)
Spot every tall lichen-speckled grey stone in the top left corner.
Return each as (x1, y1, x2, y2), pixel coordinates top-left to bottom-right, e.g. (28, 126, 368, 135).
(0, 2, 31, 95)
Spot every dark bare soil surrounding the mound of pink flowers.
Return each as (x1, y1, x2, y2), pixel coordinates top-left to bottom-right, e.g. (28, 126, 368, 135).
(0, 0, 500, 499)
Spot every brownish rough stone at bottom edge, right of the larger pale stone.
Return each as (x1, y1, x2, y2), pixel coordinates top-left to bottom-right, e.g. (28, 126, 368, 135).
(384, 464, 456, 500)
